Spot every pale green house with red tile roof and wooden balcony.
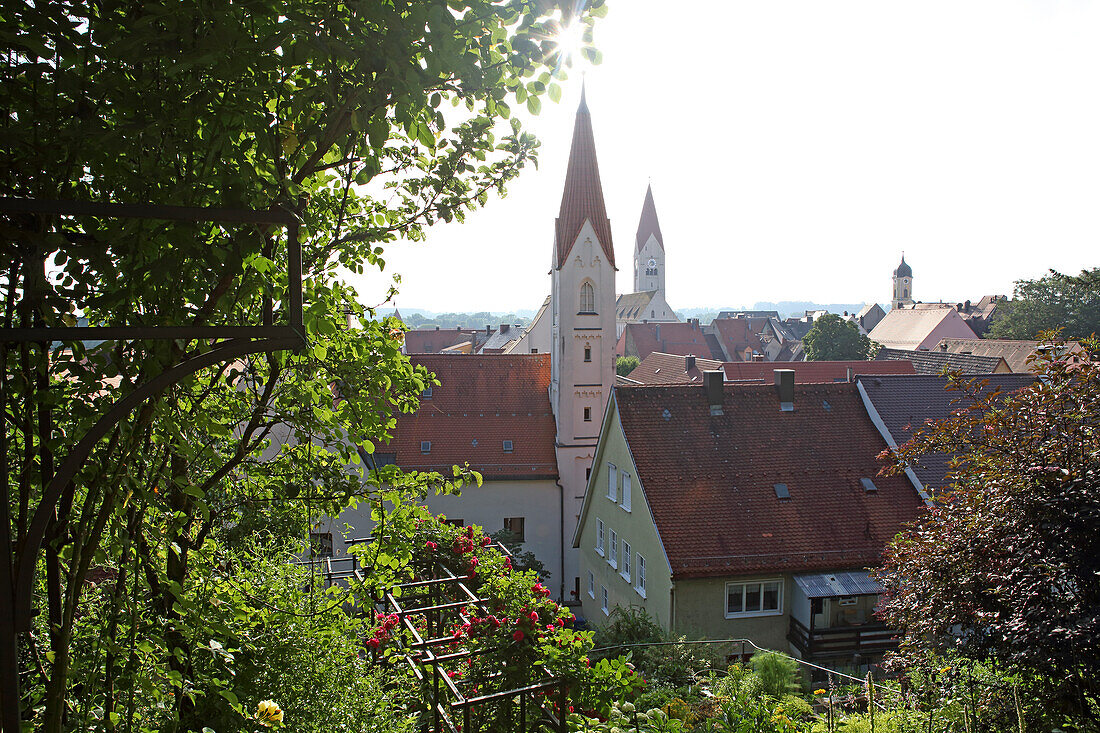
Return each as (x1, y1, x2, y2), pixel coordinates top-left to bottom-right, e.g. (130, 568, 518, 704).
(573, 370, 924, 661)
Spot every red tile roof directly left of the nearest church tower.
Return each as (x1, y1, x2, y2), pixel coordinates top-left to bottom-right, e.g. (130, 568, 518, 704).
(387, 353, 558, 479)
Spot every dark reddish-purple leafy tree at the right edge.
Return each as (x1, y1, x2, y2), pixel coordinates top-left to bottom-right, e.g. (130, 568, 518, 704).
(880, 342, 1100, 716)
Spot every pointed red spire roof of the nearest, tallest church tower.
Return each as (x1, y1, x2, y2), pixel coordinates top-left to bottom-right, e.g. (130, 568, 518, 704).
(554, 90, 615, 267)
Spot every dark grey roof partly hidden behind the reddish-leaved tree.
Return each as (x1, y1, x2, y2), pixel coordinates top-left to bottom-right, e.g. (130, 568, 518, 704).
(859, 374, 1035, 489)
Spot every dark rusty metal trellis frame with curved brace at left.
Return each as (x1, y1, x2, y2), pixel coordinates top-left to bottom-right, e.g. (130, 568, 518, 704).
(0, 198, 306, 733)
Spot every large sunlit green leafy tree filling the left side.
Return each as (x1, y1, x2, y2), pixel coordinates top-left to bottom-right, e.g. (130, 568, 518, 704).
(0, 0, 602, 733)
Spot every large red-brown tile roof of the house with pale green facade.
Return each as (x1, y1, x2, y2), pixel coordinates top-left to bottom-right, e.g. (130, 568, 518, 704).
(615, 383, 923, 578)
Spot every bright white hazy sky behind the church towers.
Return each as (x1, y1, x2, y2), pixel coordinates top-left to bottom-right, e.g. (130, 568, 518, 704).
(349, 0, 1100, 311)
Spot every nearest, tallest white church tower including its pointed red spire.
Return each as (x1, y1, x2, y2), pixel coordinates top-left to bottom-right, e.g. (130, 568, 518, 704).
(550, 89, 615, 595)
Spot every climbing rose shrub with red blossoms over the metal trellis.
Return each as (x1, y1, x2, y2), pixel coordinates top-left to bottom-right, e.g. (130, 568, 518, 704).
(353, 506, 642, 720)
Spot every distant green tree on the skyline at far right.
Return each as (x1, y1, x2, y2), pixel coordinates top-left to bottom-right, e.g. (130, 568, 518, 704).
(989, 267, 1100, 339)
